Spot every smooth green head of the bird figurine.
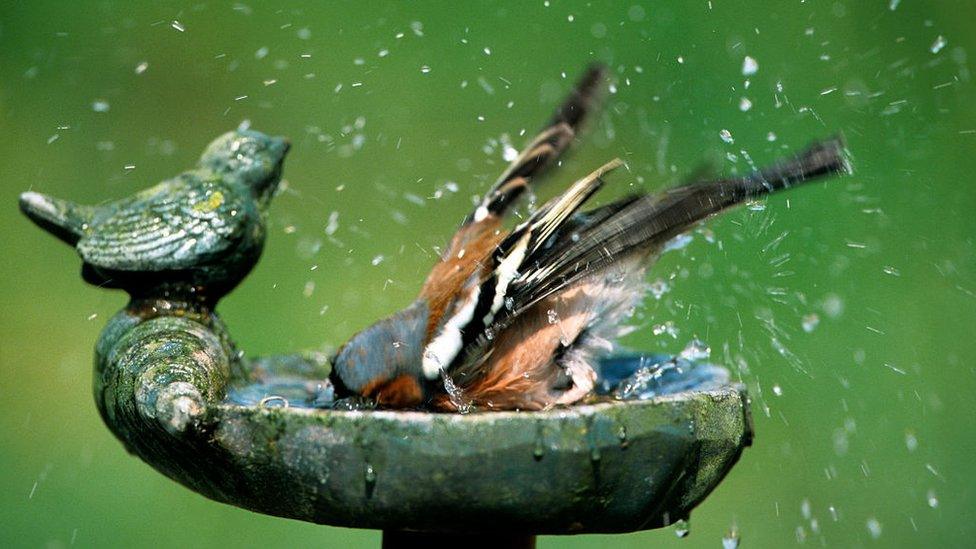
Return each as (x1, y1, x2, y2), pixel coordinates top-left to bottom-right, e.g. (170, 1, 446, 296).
(200, 129, 291, 203)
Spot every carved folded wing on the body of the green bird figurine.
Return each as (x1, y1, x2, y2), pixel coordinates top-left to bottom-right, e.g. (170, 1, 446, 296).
(77, 172, 259, 272)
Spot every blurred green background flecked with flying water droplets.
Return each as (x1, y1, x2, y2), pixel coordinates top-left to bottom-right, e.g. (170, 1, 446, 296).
(0, 0, 976, 548)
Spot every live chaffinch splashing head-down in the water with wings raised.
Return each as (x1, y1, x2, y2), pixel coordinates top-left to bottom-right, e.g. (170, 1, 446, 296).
(332, 67, 850, 412)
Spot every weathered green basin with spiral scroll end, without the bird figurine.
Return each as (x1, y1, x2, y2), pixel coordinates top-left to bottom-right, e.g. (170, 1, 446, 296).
(95, 309, 752, 547)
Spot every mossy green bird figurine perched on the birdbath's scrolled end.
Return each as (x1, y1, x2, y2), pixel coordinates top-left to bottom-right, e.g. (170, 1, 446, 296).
(20, 128, 289, 304)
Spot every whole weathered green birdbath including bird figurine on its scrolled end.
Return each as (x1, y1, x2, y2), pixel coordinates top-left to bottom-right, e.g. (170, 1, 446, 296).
(21, 127, 752, 547)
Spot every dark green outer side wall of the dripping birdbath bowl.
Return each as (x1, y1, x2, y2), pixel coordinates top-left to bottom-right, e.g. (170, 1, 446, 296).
(158, 374, 752, 534)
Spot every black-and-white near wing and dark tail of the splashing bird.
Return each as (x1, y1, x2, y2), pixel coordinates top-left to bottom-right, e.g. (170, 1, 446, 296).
(452, 138, 850, 375)
